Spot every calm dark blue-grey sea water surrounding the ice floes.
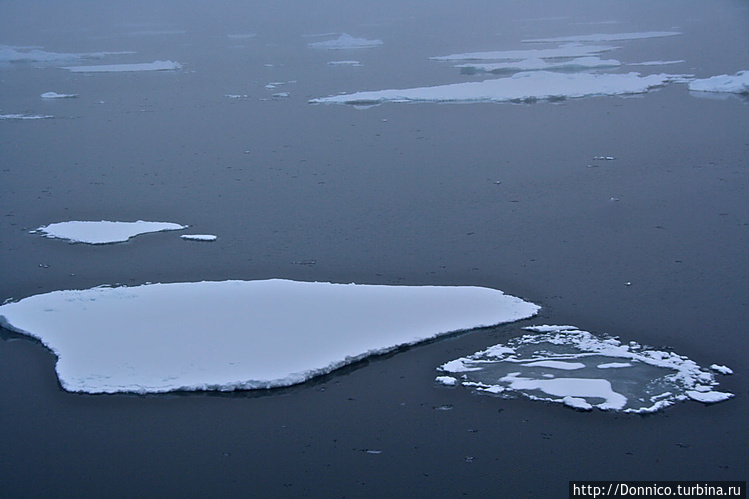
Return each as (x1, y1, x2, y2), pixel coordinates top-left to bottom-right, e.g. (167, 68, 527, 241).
(0, 1, 749, 497)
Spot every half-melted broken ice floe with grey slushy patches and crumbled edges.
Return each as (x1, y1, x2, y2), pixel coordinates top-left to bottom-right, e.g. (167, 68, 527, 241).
(437, 326, 733, 414)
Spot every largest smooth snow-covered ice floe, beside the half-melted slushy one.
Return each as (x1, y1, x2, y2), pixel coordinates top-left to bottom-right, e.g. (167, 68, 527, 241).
(0, 279, 539, 393)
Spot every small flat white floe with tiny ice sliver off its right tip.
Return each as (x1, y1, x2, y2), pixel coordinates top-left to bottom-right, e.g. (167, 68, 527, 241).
(31, 220, 187, 244)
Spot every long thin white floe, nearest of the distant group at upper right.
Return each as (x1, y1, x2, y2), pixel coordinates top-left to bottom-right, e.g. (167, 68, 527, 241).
(309, 71, 681, 104)
